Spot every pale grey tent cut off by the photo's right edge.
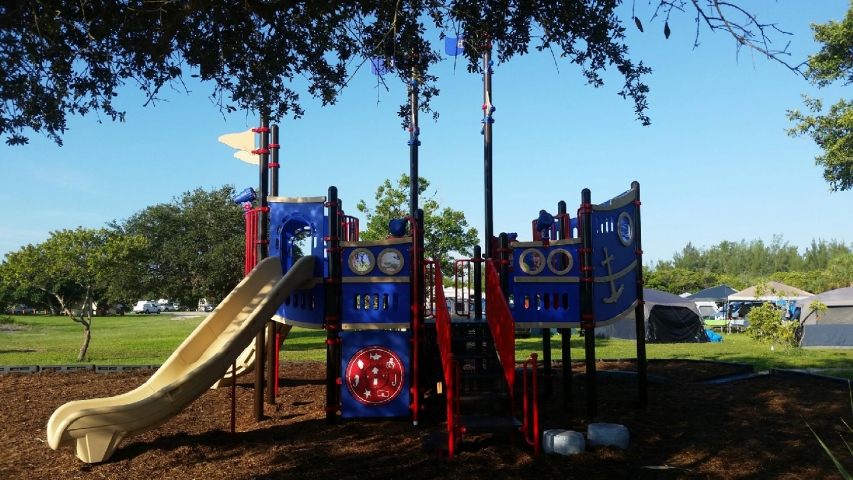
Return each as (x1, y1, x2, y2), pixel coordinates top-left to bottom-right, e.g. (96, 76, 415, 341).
(796, 287, 853, 348)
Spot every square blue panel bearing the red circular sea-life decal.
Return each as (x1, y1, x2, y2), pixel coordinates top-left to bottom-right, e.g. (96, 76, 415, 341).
(341, 330, 411, 418)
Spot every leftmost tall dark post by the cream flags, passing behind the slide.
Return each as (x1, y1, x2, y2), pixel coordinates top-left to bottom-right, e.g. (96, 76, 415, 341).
(253, 115, 269, 422)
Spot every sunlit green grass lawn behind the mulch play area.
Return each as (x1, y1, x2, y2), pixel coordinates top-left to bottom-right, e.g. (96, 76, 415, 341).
(0, 313, 853, 378)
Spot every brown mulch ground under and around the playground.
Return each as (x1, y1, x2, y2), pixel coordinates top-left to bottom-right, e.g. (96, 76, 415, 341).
(0, 361, 853, 480)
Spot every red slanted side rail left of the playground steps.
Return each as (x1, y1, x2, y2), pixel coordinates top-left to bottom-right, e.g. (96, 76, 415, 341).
(433, 265, 462, 458)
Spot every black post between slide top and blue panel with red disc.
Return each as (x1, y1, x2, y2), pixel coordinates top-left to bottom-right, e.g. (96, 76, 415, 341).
(325, 187, 341, 423)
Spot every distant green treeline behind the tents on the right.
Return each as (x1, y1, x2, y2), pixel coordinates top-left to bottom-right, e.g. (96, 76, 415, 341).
(644, 235, 853, 294)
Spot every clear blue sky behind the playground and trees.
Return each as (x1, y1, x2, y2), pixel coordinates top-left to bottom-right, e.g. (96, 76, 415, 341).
(0, 0, 853, 263)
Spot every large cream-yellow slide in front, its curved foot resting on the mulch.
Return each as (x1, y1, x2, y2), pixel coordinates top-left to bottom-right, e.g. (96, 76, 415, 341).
(47, 256, 315, 463)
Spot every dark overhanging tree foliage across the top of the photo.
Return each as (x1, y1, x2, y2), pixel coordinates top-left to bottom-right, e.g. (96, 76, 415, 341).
(0, 0, 796, 145)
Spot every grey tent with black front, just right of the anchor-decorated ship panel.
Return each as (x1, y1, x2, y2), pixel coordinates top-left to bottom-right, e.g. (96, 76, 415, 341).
(595, 288, 708, 343)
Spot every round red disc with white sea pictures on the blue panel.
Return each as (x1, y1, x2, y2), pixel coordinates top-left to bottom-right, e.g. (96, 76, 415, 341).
(345, 345, 406, 407)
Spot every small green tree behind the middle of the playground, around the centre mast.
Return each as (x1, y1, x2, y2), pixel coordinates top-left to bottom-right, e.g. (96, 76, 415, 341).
(357, 174, 479, 277)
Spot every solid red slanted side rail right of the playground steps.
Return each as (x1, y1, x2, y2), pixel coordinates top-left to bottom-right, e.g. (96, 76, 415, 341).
(486, 259, 515, 397)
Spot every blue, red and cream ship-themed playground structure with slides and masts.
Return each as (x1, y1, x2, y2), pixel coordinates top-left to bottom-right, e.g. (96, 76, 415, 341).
(48, 42, 647, 462)
